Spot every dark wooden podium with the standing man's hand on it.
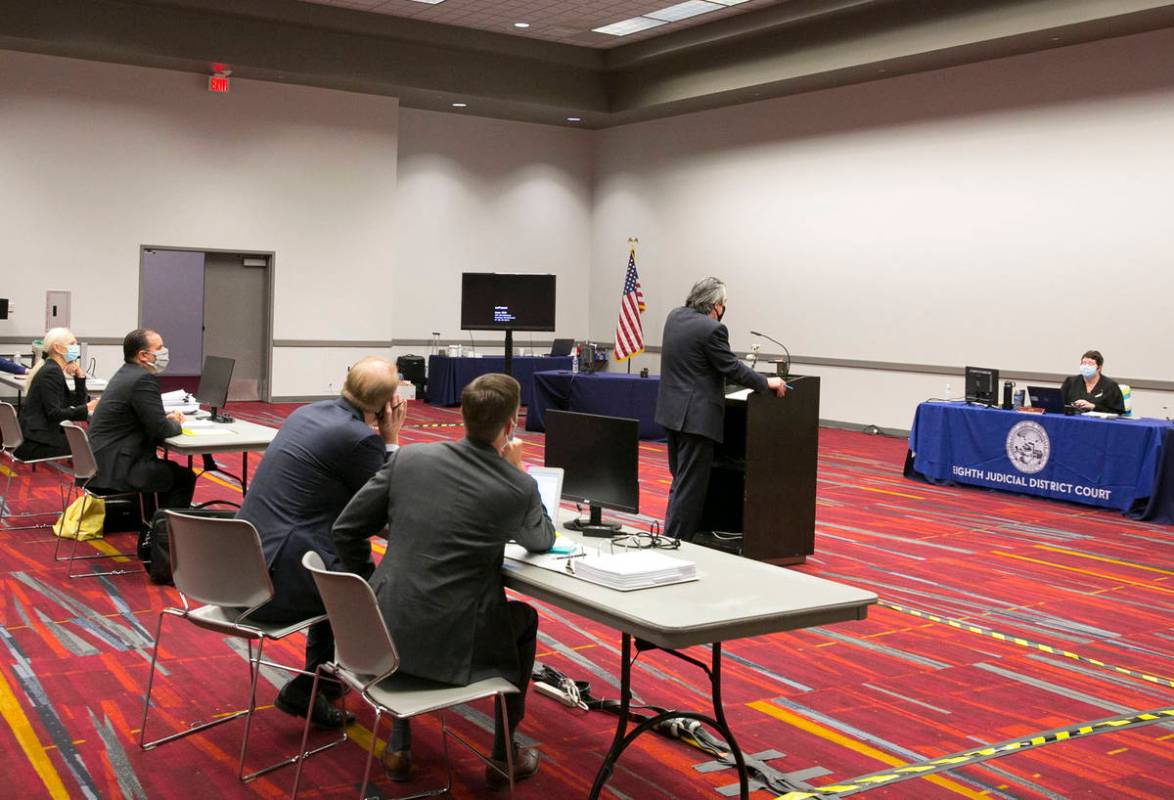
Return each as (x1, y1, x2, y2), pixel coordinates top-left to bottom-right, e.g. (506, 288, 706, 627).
(696, 375, 819, 564)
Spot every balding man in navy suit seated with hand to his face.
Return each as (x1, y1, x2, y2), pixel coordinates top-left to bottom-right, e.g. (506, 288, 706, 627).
(237, 356, 407, 728)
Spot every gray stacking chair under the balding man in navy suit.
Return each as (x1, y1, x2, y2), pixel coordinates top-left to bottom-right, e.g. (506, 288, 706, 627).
(139, 511, 346, 781)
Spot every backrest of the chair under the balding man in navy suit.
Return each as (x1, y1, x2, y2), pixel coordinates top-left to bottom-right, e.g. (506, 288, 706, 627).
(167, 511, 274, 609)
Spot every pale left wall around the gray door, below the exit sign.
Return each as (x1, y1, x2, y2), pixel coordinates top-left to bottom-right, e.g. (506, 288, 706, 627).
(0, 51, 398, 395)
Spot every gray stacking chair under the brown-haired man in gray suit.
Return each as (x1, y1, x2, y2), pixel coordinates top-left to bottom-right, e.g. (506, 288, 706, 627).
(290, 551, 518, 800)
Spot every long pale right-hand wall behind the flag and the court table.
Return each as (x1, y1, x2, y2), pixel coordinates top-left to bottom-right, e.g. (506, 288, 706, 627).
(592, 31, 1174, 428)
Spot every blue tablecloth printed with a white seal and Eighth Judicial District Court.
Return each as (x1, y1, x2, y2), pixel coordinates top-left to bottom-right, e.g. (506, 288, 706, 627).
(906, 403, 1174, 511)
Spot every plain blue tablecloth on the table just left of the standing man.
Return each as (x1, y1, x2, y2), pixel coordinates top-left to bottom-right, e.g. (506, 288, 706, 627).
(526, 370, 664, 439)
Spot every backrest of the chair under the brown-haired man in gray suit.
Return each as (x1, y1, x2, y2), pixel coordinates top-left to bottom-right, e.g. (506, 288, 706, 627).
(302, 550, 399, 678)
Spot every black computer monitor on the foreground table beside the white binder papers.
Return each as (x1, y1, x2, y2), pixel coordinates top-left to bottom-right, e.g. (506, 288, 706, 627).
(544, 411, 640, 536)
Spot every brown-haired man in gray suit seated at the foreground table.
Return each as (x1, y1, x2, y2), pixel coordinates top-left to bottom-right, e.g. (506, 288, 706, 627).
(333, 374, 554, 788)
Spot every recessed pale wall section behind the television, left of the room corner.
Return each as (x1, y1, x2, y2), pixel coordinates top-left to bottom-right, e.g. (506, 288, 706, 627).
(391, 108, 592, 352)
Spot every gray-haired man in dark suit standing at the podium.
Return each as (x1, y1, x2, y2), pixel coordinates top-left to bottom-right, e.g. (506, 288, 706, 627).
(656, 277, 787, 542)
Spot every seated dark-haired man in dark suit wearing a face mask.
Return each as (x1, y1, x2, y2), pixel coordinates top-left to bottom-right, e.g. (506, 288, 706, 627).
(89, 328, 196, 509)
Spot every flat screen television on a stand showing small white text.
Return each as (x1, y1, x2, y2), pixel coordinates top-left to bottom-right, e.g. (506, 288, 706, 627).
(460, 273, 555, 330)
